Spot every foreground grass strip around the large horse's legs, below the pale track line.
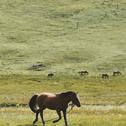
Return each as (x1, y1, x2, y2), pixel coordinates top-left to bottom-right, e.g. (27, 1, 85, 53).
(0, 107, 126, 126)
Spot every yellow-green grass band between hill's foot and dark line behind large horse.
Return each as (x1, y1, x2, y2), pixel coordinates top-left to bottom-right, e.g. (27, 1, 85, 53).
(0, 75, 126, 105)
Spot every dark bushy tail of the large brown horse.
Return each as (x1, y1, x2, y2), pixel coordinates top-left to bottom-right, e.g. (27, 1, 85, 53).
(29, 94, 38, 113)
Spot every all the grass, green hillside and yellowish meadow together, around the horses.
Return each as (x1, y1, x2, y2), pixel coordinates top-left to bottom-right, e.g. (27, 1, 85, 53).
(0, 0, 126, 126)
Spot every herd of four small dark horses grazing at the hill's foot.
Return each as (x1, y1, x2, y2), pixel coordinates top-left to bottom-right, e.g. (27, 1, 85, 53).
(47, 70, 122, 79)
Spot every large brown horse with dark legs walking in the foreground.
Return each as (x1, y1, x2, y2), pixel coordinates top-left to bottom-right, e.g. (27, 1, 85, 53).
(29, 91, 81, 126)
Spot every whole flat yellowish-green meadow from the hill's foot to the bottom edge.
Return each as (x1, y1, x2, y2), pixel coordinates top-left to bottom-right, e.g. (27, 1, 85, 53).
(0, 75, 126, 126)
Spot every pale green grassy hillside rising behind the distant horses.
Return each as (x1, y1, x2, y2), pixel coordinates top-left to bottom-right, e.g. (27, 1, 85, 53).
(0, 0, 126, 74)
